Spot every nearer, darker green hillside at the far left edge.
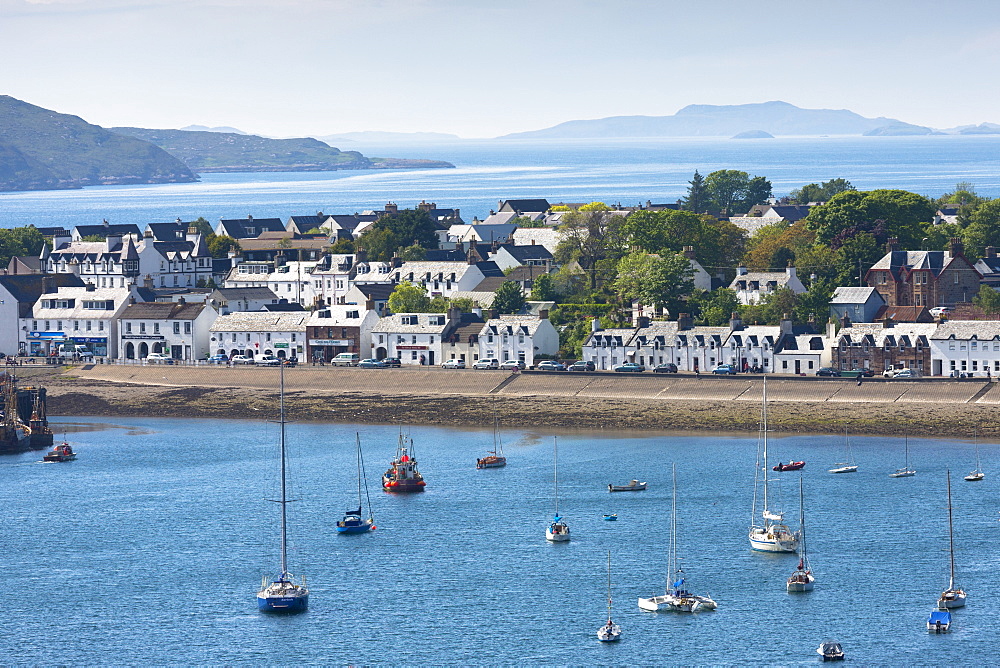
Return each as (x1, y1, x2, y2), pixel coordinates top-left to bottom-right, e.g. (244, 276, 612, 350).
(0, 95, 197, 191)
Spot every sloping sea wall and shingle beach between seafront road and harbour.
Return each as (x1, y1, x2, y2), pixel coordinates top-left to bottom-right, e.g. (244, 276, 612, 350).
(19, 365, 1000, 438)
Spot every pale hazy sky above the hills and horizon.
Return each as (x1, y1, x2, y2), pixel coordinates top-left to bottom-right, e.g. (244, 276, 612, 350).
(0, 0, 1000, 137)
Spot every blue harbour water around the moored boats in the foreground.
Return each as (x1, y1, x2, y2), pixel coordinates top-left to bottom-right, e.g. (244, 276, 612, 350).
(0, 418, 1000, 665)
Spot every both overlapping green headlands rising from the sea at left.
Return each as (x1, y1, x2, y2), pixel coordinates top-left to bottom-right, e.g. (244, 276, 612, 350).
(0, 95, 454, 191)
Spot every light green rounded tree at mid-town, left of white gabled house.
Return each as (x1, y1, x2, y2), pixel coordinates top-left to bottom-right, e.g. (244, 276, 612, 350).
(614, 253, 694, 312)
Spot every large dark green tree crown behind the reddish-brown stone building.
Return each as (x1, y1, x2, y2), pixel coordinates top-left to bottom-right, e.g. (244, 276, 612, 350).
(805, 190, 935, 250)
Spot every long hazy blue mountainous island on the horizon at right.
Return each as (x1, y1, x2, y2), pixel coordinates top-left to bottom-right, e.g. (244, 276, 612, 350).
(500, 102, 1000, 139)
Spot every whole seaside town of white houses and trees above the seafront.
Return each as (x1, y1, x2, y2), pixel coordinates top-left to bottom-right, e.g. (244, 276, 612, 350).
(0, 177, 1000, 378)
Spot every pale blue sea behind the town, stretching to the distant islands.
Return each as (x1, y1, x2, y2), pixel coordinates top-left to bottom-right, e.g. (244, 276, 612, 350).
(0, 136, 1000, 227)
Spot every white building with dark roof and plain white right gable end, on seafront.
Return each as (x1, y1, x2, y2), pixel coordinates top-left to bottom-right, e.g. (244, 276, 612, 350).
(118, 298, 218, 361)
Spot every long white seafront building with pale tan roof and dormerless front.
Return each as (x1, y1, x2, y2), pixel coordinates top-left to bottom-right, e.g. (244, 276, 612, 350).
(210, 311, 309, 359)
